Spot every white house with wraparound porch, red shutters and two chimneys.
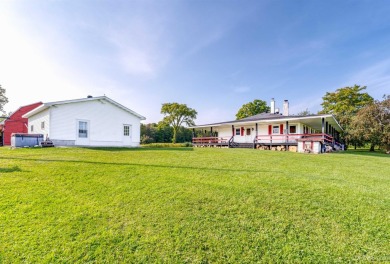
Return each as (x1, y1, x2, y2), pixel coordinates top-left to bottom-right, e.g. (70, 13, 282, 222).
(192, 99, 343, 153)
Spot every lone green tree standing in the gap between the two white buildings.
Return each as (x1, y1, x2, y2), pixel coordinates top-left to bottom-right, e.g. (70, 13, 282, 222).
(161, 103, 198, 143)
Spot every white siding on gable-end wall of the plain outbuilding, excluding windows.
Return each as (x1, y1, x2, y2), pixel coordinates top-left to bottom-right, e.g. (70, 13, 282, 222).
(49, 100, 140, 147)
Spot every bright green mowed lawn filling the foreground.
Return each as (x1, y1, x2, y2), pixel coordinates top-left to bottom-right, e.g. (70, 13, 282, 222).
(0, 147, 390, 263)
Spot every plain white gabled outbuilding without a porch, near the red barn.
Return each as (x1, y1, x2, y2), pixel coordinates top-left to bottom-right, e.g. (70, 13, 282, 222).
(23, 96, 145, 147)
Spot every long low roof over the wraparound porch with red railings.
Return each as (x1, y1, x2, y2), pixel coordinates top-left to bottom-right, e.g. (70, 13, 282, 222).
(189, 113, 343, 132)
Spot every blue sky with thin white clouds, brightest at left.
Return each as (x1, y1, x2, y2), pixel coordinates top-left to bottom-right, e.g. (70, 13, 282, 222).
(0, 0, 390, 124)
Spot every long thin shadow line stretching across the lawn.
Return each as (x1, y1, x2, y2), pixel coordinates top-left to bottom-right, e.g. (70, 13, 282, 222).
(0, 157, 289, 174)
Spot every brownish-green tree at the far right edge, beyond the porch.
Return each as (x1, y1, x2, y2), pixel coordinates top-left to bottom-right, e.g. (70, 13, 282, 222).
(348, 96, 390, 151)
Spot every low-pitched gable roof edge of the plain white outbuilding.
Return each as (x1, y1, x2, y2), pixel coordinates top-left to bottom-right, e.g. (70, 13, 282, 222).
(23, 96, 146, 120)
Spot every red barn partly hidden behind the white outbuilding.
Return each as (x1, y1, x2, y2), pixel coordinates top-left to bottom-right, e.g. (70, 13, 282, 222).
(3, 102, 42, 145)
